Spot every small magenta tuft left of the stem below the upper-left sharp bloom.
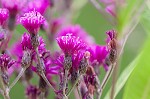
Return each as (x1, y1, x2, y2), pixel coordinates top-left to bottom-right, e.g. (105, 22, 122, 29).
(21, 33, 33, 50)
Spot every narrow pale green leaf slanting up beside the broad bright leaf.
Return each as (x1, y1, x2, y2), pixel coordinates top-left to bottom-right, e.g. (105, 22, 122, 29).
(104, 54, 141, 99)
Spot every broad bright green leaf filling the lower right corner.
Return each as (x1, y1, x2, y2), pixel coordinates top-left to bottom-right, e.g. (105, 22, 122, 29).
(123, 38, 150, 99)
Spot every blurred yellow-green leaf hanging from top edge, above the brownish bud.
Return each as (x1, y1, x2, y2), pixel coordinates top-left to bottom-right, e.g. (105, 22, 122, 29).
(117, 0, 145, 32)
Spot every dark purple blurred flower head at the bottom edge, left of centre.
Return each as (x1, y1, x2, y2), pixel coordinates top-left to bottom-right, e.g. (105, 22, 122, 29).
(26, 85, 40, 99)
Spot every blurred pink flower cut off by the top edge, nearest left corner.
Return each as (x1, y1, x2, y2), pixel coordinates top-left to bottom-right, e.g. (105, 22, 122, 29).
(1, 0, 27, 16)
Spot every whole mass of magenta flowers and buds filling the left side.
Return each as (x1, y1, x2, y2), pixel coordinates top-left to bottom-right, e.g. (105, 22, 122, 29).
(0, 0, 116, 99)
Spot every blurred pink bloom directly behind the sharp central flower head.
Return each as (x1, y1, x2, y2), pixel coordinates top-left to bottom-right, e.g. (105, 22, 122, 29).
(58, 25, 94, 44)
